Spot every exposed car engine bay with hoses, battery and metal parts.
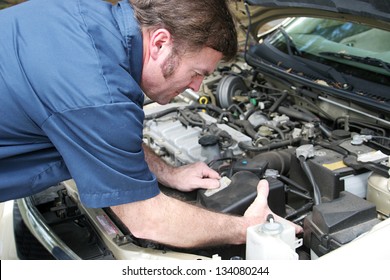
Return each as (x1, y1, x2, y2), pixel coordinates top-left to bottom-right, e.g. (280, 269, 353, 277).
(144, 56, 390, 259)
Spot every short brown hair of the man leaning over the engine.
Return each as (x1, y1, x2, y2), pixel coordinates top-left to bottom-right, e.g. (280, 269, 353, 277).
(130, 0, 237, 60)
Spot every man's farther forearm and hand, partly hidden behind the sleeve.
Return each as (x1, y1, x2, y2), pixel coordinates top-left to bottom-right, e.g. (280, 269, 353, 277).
(143, 144, 220, 191)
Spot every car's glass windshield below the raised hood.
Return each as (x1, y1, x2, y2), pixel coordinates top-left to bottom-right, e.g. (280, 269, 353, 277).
(267, 17, 390, 80)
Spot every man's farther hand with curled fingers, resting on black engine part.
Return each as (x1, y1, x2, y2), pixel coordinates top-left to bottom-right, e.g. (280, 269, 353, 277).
(171, 162, 221, 192)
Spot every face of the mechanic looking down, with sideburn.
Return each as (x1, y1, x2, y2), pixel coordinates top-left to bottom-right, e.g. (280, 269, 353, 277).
(141, 30, 222, 104)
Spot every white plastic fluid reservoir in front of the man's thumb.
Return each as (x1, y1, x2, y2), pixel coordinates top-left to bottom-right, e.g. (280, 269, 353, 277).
(246, 215, 302, 260)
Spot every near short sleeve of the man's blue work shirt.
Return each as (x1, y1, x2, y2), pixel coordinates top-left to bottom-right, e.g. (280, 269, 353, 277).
(42, 102, 159, 208)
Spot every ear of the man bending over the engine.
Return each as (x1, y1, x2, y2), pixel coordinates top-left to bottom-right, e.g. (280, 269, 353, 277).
(149, 28, 173, 60)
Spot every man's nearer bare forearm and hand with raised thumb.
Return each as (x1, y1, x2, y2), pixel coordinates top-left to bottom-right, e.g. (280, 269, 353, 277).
(112, 180, 302, 248)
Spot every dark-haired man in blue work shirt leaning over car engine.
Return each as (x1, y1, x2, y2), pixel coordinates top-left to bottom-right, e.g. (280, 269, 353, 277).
(0, 0, 300, 247)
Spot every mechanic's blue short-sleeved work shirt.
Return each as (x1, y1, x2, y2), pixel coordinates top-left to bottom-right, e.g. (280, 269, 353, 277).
(0, 0, 159, 208)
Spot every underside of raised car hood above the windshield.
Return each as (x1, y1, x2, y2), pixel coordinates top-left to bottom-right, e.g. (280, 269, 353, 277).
(232, 0, 390, 37)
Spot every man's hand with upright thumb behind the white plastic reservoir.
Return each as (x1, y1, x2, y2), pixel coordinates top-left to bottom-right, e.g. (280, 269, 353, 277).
(244, 180, 303, 233)
